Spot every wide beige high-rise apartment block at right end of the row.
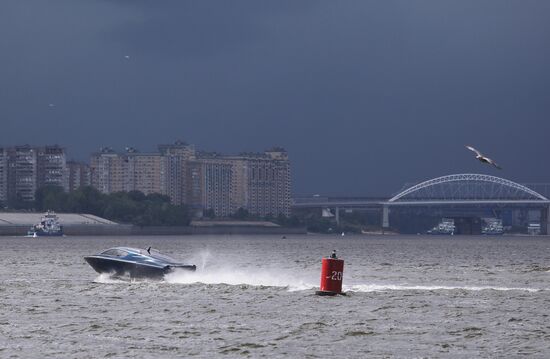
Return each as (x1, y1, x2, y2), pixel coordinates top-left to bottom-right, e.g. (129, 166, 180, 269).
(188, 148, 290, 217)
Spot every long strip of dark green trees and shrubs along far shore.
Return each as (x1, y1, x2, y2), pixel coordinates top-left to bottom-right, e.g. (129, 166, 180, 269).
(1, 186, 381, 234)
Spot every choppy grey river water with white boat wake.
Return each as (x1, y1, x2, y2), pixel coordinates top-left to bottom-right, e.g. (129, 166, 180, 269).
(0, 235, 550, 358)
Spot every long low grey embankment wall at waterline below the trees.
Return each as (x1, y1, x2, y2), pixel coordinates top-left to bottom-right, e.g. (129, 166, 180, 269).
(0, 224, 306, 236)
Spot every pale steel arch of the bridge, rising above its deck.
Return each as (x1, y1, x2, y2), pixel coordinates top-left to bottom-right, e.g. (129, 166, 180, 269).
(388, 173, 548, 203)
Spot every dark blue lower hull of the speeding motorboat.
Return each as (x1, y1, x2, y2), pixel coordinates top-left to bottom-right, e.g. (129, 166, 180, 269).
(84, 256, 196, 279)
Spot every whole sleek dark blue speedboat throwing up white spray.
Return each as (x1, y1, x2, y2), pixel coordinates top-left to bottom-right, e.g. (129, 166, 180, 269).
(84, 247, 197, 278)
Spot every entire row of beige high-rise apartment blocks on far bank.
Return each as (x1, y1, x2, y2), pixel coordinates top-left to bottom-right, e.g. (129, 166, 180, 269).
(0, 141, 291, 217)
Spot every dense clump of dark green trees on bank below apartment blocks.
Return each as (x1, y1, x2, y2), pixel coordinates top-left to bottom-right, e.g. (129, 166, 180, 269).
(34, 186, 191, 226)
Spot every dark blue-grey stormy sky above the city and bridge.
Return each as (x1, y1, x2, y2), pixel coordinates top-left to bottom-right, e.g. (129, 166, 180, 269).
(0, 0, 550, 195)
